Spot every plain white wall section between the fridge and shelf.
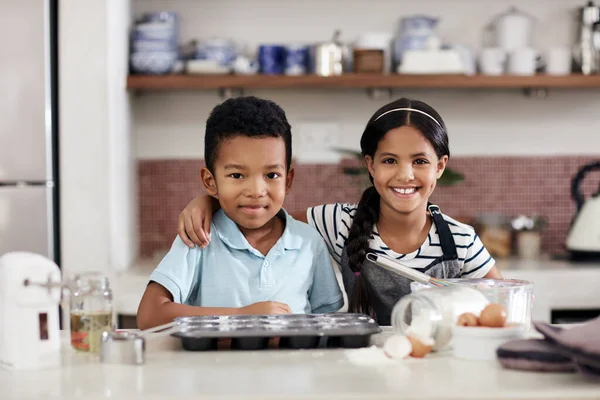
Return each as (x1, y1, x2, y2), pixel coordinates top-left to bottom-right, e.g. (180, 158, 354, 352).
(59, 0, 138, 275)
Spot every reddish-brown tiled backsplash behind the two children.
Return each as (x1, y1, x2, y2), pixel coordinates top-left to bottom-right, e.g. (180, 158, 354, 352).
(138, 156, 600, 257)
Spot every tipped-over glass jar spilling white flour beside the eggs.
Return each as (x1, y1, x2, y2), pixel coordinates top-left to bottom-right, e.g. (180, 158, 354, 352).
(391, 285, 489, 350)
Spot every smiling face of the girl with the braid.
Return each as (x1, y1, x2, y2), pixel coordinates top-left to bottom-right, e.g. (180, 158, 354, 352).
(365, 126, 448, 214)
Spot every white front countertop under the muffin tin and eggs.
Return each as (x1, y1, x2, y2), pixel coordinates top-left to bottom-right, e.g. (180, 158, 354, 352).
(0, 331, 600, 400)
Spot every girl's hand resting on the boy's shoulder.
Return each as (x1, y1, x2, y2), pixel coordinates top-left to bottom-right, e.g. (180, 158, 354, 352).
(177, 195, 213, 248)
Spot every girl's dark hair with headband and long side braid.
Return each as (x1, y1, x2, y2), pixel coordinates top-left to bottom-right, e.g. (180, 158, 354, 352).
(346, 98, 450, 315)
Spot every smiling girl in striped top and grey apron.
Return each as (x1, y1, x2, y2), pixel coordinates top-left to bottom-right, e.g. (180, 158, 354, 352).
(179, 98, 502, 325)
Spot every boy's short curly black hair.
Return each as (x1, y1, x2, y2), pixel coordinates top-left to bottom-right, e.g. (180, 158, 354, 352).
(204, 96, 292, 172)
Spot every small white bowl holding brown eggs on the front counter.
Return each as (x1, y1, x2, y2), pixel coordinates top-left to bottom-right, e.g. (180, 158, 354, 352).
(452, 325, 527, 361)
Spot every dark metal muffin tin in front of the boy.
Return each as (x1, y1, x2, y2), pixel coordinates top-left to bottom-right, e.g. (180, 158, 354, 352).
(173, 313, 381, 351)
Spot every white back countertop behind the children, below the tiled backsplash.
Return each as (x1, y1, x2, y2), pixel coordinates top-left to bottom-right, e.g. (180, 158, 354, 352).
(112, 259, 600, 322)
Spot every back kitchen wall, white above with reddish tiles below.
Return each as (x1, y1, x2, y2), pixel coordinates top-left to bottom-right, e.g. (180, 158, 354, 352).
(133, 0, 600, 256)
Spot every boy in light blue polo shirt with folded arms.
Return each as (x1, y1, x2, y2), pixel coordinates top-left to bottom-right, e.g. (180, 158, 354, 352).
(137, 97, 343, 329)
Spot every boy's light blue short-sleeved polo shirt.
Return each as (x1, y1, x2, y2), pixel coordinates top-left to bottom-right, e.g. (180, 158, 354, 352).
(150, 209, 343, 314)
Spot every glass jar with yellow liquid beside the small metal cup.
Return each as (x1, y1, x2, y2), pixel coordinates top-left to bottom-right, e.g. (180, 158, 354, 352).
(69, 272, 115, 353)
